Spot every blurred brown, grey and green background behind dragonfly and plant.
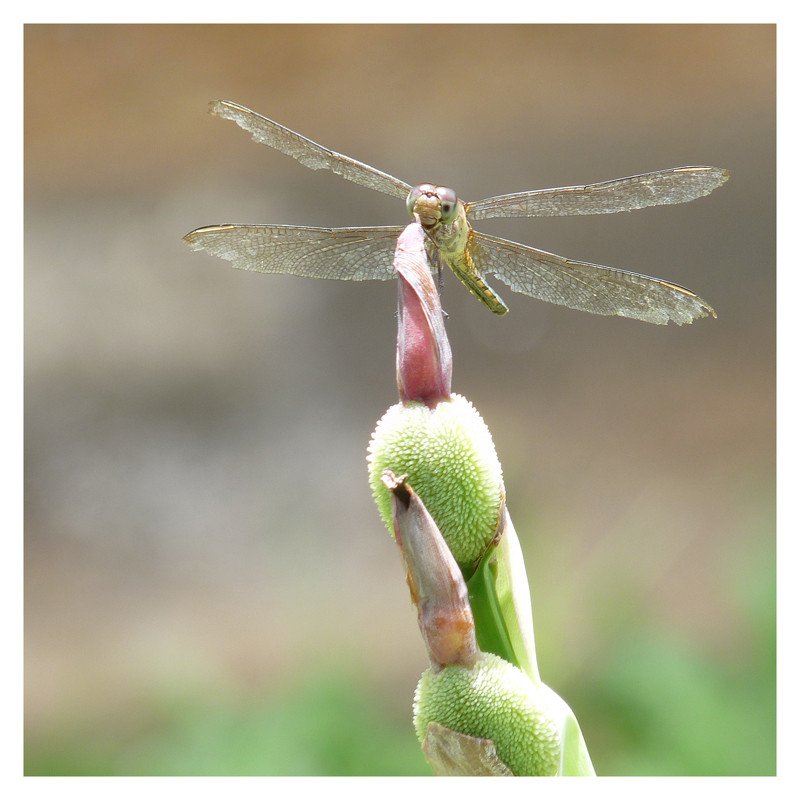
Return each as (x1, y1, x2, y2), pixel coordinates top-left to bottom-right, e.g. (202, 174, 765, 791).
(25, 25, 775, 775)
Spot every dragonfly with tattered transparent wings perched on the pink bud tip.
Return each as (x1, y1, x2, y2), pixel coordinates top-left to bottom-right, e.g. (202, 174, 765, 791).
(184, 100, 729, 325)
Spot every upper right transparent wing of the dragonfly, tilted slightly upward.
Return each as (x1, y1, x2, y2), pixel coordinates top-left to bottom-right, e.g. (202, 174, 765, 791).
(467, 167, 729, 219)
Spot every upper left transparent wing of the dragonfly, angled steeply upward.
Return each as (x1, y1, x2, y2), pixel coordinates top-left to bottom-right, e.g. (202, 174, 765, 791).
(209, 100, 411, 200)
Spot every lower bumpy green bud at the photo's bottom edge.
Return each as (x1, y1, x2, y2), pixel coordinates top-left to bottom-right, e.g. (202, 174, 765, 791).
(414, 653, 561, 776)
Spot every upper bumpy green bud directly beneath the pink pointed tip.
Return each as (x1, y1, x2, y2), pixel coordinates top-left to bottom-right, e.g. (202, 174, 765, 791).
(367, 394, 505, 568)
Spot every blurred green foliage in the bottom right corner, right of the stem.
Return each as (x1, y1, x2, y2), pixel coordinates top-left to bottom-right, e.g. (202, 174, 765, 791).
(564, 536, 777, 776)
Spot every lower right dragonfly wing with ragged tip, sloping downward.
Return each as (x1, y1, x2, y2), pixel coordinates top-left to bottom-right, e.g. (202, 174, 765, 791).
(469, 231, 717, 325)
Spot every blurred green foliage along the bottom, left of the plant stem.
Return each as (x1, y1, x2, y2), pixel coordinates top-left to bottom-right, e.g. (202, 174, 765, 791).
(25, 674, 430, 776)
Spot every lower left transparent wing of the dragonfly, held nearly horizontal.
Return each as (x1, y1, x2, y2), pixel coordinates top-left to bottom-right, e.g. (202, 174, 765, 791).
(183, 225, 403, 281)
